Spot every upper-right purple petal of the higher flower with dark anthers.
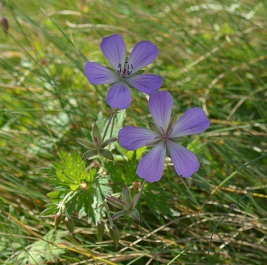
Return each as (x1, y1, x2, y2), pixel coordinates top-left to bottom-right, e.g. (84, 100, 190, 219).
(128, 41, 159, 74)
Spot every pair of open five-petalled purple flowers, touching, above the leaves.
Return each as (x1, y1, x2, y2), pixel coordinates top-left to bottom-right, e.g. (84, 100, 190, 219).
(85, 34, 210, 182)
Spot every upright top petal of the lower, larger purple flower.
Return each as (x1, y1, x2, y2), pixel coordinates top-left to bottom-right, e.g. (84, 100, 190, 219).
(148, 90, 173, 133)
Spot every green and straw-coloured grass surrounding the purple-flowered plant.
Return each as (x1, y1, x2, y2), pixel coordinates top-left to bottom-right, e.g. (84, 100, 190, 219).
(0, 0, 267, 265)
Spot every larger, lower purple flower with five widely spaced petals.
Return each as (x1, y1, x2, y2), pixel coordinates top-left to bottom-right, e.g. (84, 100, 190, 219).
(119, 91, 210, 182)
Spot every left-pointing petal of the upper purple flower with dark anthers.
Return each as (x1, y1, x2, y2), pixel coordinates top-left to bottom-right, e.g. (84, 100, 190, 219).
(85, 62, 119, 85)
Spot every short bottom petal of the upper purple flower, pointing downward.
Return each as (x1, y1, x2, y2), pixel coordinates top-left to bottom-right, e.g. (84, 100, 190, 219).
(107, 82, 132, 109)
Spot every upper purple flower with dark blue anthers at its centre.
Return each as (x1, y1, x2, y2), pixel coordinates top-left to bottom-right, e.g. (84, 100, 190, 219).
(85, 34, 162, 109)
